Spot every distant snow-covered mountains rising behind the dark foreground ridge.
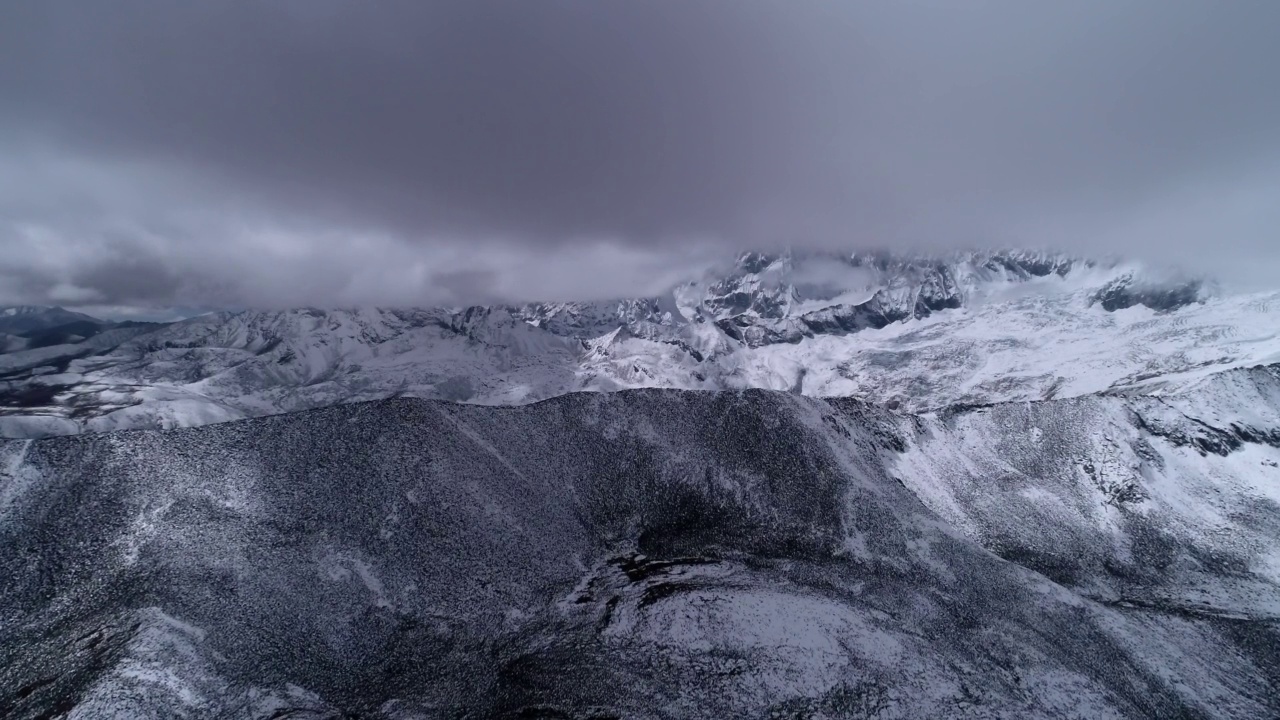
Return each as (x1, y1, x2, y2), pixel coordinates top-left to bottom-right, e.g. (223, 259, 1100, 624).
(0, 252, 1280, 437)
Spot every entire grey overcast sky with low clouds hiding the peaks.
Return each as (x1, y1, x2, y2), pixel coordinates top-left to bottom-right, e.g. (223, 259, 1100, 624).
(0, 0, 1280, 306)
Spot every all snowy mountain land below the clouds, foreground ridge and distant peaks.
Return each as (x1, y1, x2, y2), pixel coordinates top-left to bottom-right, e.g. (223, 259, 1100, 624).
(0, 252, 1280, 720)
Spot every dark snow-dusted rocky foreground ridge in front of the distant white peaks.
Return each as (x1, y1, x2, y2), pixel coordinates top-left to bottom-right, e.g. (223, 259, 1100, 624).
(0, 381, 1280, 719)
